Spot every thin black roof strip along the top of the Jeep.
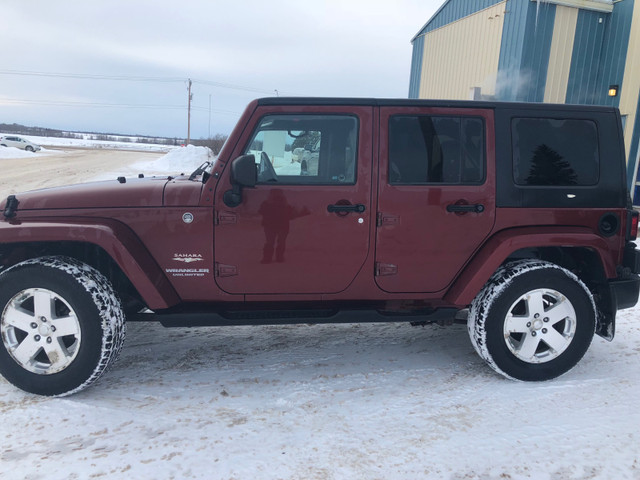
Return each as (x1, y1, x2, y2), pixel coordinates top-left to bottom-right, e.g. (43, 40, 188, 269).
(258, 97, 617, 112)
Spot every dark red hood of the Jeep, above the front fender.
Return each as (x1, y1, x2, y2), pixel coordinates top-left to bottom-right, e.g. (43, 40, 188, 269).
(2, 173, 169, 211)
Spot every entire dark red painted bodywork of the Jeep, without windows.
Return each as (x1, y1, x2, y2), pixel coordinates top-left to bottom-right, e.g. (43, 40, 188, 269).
(0, 101, 626, 316)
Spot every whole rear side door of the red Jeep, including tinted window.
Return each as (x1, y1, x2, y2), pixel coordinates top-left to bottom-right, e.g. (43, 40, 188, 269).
(375, 106, 495, 292)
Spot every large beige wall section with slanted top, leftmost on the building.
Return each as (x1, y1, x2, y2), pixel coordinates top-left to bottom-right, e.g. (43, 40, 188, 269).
(419, 2, 506, 100)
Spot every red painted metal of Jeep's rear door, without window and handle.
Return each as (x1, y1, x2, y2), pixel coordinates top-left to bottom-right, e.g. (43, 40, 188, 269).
(376, 107, 496, 293)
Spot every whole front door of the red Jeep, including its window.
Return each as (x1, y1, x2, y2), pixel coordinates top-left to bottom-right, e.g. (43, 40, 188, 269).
(215, 105, 375, 295)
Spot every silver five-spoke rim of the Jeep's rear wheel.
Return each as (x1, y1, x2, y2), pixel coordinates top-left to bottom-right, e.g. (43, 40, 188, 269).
(504, 288, 577, 363)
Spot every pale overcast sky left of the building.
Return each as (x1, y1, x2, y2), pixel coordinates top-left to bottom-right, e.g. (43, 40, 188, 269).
(0, 0, 444, 138)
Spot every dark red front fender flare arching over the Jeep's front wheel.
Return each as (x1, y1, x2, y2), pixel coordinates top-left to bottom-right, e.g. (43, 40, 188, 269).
(0, 218, 180, 309)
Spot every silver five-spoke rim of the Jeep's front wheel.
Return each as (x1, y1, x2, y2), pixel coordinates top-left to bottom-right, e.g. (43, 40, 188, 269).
(0, 288, 81, 375)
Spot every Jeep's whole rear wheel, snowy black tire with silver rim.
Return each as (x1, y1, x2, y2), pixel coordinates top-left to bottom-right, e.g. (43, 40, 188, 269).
(467, 260, 596, 381)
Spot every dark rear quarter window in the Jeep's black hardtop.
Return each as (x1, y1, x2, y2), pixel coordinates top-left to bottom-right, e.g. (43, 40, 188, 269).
(511, 118, 600, 186)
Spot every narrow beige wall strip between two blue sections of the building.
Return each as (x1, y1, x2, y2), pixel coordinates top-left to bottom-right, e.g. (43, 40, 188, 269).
(544, 6, 578, 103)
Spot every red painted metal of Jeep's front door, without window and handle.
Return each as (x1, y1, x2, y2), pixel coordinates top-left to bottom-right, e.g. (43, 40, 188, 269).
(215, 107, 375, 295)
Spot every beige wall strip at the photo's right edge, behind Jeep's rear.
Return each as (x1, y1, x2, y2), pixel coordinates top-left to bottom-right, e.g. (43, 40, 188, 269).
(620, 0, 640, 161)
